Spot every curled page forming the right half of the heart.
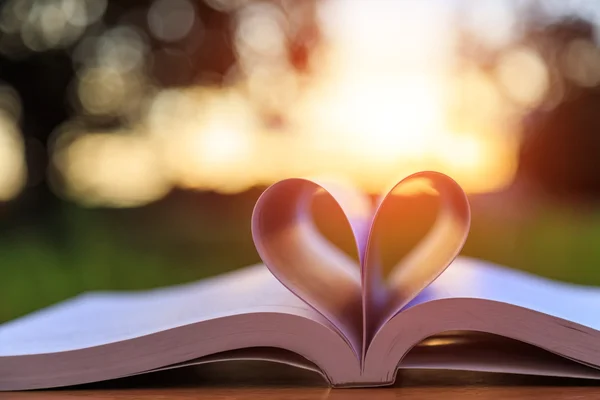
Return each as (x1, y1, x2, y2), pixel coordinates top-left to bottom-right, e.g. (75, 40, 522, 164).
(362, 171, 471, 350)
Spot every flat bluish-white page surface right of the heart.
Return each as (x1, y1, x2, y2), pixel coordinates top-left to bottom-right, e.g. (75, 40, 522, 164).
(408, 257, 600, 330)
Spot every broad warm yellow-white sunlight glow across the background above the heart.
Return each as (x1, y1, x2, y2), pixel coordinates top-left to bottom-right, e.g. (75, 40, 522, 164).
(47, 0, 524, 206)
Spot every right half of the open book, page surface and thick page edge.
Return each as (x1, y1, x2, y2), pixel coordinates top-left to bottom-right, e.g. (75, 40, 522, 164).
(364, 257, 600, 382)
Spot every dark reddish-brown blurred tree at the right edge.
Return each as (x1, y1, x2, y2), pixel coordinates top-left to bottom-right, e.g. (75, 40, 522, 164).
(518, 18, 600, 196)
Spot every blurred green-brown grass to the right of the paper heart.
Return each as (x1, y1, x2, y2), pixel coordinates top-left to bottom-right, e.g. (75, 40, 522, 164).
(463, 199, 600, 286)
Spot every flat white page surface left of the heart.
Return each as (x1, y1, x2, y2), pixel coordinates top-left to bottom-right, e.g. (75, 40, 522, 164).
(0, 265, 329, 357)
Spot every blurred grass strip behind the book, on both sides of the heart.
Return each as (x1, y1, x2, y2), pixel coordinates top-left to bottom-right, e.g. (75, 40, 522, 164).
(0, 189, 600, 322)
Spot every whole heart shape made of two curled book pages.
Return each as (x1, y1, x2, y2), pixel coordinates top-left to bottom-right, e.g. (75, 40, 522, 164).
(252, 171, 470, 359)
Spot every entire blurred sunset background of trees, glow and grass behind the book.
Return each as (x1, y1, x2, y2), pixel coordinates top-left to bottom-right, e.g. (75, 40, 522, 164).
(0, 0, 600, 322)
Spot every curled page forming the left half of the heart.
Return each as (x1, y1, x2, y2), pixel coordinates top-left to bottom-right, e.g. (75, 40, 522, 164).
(252, 179, 372, 353)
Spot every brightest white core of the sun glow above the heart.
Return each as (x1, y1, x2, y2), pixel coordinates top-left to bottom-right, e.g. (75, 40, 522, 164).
(307, 77, 442, 165)
